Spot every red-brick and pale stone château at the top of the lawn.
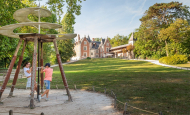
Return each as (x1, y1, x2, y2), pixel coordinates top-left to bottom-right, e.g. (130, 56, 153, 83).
(72, 34, 111, 60)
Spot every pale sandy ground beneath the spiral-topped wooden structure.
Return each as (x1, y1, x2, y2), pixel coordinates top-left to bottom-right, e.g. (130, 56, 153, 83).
(0, 89, 122, 115)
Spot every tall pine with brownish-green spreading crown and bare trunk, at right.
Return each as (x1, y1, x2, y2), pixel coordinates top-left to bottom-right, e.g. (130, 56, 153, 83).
(140, 2, 190, 56)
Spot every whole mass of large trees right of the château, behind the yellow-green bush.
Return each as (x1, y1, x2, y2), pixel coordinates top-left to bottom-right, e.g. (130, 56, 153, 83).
(134, 2, 190, 59)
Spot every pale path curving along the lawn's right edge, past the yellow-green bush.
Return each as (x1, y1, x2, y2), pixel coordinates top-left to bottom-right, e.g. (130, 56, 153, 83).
(133, 59, 190, 70)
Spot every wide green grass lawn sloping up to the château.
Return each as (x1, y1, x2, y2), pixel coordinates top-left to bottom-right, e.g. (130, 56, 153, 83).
(0, 58, 190, 115)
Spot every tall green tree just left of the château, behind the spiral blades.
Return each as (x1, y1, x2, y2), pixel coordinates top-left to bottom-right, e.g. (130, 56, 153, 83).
(58, 0, 85, 62)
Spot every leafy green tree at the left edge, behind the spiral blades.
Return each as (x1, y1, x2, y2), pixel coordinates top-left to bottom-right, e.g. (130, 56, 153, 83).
(0, 0, 26, 68)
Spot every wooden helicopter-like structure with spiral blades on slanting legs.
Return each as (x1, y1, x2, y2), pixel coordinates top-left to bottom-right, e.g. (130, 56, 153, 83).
(0, 7, 76, 108)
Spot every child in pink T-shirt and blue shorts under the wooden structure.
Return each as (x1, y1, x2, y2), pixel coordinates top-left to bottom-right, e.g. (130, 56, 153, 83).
(41, 63, 53, 101)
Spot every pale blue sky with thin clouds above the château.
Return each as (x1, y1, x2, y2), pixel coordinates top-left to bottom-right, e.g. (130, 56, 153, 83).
(40, 0, 190, 38)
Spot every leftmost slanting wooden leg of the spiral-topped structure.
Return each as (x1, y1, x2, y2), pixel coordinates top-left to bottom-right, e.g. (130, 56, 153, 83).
(0, 38, 23, 100)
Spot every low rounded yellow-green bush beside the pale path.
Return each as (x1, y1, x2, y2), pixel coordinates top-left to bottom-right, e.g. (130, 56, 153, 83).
(159, 55, 188, 65)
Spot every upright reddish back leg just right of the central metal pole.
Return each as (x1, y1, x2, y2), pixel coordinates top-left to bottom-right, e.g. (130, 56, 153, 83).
(40, 42, 44, 93)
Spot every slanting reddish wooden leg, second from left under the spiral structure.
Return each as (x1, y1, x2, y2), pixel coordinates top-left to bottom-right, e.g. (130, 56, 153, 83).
(9, 41, 26, 97)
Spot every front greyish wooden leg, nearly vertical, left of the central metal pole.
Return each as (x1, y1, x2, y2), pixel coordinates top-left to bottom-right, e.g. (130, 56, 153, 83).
(30, 36, 38, 109)
